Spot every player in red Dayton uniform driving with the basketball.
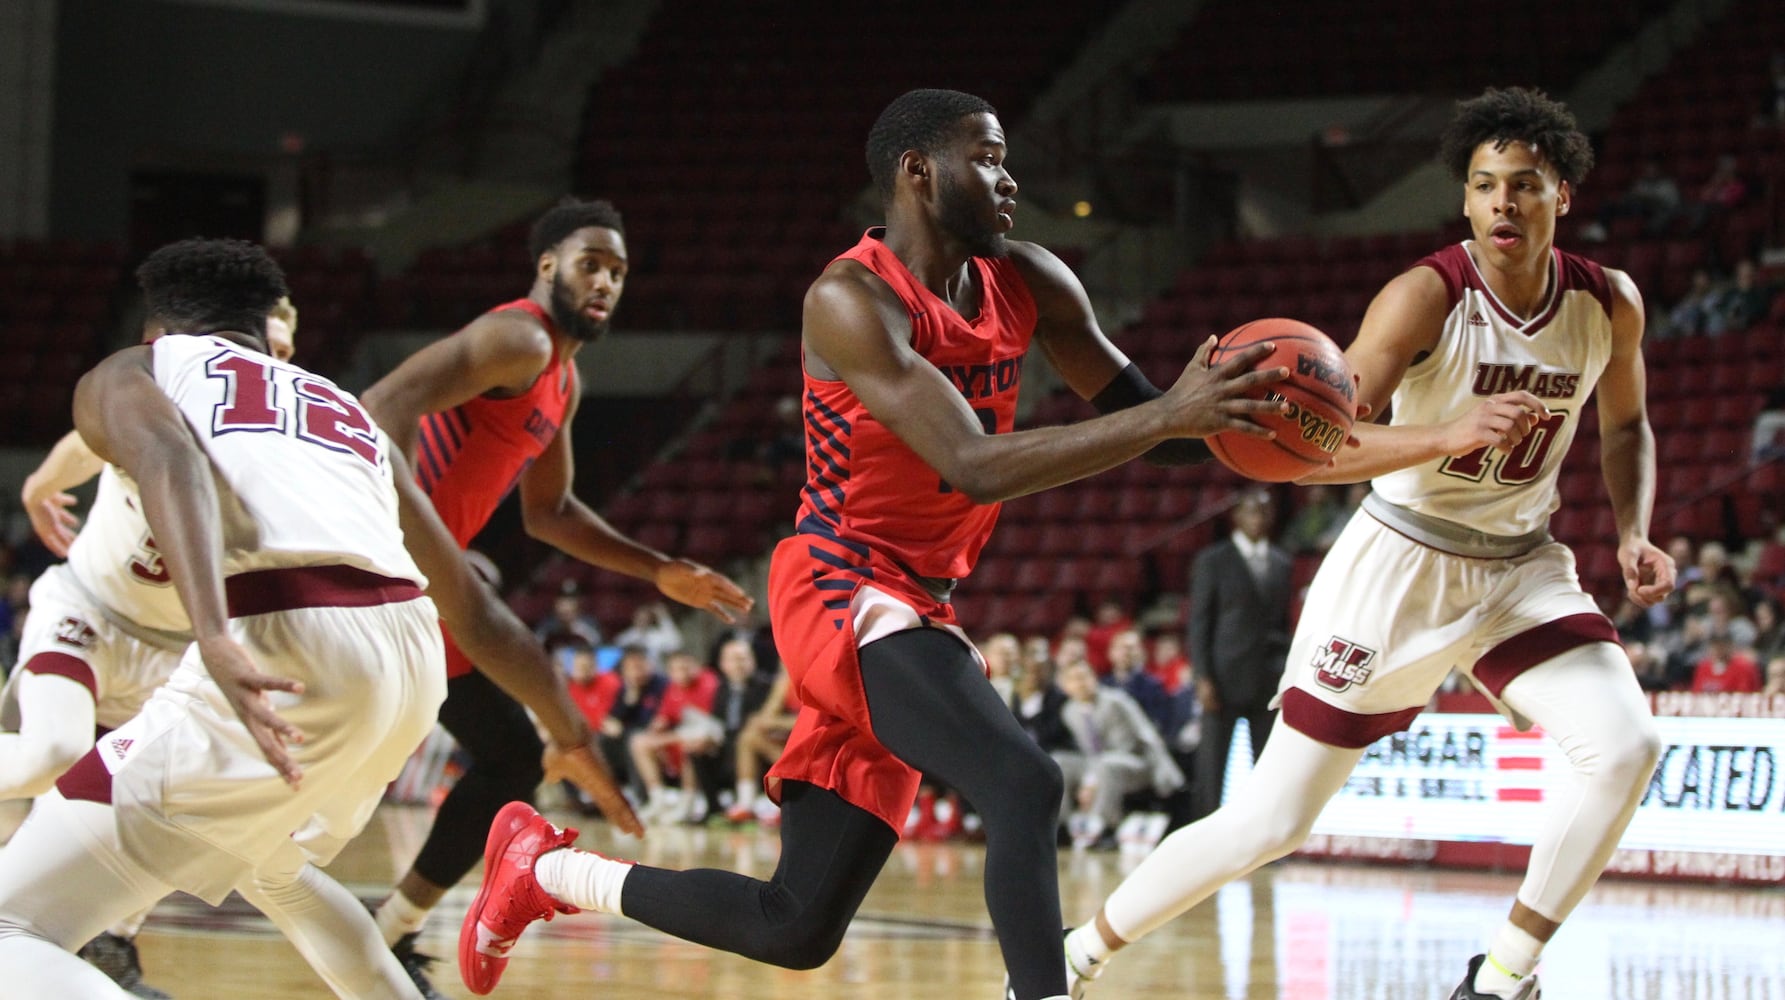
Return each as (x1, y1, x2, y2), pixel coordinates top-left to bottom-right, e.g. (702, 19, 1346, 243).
(459, 91, 1287, 1000)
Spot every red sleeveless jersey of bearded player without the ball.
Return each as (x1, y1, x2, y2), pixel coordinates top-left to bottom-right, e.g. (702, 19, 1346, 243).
(416, 298, 577, 548)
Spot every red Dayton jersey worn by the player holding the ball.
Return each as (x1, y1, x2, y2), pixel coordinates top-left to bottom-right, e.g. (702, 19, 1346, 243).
(798, 229, 1035, 579)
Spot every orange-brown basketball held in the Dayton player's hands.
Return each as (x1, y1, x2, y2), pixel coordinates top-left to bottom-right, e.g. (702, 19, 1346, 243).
(1208, 318, 1357, 482)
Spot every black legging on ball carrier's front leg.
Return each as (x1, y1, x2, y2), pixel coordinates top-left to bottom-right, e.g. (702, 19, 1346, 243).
(860, 629, 1066, 1000)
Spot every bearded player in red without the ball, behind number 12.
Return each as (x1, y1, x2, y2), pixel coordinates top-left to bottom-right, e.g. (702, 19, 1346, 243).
(364, 200, 751, 985)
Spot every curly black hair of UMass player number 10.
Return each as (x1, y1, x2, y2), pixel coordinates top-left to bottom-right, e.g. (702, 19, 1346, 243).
(1439, 88, 1592, 186)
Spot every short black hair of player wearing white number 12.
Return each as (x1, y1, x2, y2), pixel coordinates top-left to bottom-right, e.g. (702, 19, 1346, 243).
(136, 239, 289, 338)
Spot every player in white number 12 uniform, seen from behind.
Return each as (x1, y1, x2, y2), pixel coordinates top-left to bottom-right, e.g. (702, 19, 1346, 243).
(0, 241, 585, 1000)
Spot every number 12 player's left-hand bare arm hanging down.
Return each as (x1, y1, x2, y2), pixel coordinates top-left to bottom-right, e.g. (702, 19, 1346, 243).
(75, 346, 303, 786)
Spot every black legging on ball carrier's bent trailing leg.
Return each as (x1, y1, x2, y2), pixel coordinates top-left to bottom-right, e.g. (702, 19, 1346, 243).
(619, 782, 899, 970)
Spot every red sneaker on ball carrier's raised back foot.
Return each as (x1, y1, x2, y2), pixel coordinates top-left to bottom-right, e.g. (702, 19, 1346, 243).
(459, 802, 577, 996)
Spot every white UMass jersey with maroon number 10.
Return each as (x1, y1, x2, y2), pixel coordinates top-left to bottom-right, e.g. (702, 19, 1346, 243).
(1371, 243, 1612, 536)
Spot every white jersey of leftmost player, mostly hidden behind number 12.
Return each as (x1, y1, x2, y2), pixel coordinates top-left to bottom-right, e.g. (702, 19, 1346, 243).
(68, 466, 193, 634)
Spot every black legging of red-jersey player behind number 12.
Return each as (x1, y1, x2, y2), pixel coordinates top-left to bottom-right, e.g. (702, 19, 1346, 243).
(414, 671, 544, 888)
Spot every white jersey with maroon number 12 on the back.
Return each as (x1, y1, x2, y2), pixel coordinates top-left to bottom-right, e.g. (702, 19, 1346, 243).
(152, 334, 427, 588)
